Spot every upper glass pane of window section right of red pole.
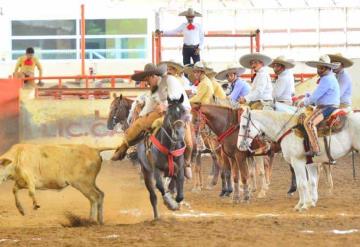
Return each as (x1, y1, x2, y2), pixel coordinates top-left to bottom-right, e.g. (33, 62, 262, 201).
(85, 19, 147, 35)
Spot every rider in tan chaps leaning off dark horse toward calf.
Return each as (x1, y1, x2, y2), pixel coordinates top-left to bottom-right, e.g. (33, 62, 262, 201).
(112, 63, 192, 178)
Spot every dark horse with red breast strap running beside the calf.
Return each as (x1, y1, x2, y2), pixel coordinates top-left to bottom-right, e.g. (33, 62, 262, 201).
(137, 96, 187, 219)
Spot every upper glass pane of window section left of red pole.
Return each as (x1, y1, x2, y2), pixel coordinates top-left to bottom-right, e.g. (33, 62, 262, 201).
(11, 20, 76, 36)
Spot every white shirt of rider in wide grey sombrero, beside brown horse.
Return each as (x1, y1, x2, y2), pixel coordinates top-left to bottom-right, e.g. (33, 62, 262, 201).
(244, 67, 272, 102)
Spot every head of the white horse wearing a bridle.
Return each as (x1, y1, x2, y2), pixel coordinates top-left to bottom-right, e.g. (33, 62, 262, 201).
(238, 108, 259, 151)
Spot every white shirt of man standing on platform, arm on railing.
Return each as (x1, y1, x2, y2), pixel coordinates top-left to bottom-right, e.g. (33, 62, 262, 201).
(164, 22, 204, 49)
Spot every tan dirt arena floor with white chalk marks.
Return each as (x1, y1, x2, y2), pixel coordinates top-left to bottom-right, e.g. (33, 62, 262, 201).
(0, 153, 360, 247)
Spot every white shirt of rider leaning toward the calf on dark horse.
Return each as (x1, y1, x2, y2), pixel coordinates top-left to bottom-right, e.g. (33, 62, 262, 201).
(139, 75, 191, 116)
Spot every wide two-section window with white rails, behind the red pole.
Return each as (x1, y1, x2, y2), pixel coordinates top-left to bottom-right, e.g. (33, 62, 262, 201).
(11, 19, 148, 59)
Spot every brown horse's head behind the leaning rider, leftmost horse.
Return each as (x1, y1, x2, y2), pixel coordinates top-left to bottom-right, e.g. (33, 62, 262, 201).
(107, 94, 131, 130)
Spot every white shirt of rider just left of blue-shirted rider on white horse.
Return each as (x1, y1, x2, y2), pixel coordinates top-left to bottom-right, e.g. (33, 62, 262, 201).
(273, 69, 295, 102)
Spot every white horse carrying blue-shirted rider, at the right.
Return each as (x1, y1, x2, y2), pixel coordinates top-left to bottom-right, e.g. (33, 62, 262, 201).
(238, 110, 360, 211)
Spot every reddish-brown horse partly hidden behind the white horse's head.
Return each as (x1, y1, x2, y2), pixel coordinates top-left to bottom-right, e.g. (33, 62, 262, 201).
(195, 105, 273, 202)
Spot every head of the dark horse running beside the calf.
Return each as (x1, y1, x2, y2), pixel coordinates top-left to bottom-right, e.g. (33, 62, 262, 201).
(163, 95, 188, 142)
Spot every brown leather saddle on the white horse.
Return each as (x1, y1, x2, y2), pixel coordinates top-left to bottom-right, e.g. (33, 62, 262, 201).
(295, 108, 347, 138)
